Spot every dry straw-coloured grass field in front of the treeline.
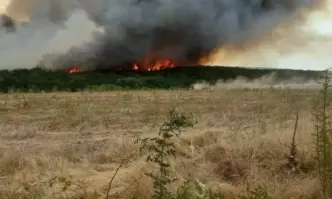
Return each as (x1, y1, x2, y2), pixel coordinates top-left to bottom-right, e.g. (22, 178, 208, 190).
(0, 89, 324, 199)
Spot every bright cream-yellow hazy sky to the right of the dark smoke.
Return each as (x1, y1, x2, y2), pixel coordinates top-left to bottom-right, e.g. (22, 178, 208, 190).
(205, 1, 332, 70)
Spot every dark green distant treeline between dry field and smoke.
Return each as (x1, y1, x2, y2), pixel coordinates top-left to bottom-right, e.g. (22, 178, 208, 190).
(0, 66, 321, 92)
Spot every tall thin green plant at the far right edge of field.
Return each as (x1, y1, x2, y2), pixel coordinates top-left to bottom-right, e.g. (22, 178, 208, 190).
(313, 70, 332, 198)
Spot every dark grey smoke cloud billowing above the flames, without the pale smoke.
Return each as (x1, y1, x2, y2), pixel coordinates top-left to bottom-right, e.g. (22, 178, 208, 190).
(0, 0, 319, 68)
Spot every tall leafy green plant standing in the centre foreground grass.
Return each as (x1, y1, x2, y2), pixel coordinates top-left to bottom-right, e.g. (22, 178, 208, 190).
(135, 109, 195, 199)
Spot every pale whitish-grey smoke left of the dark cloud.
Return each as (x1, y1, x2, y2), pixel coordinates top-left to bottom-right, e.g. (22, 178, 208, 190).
(0, 0, 104, 69)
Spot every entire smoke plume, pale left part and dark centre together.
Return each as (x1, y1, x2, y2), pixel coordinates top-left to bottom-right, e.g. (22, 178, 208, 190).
(0, 0, 321, 69)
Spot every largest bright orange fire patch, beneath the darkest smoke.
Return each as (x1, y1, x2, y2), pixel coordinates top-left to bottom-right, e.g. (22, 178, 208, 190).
(132, 59, 175, 71)
